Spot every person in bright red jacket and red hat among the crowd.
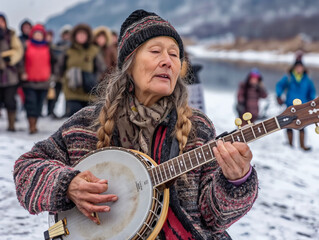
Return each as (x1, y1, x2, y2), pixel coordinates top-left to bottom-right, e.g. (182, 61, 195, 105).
(22, 24, 51, 134)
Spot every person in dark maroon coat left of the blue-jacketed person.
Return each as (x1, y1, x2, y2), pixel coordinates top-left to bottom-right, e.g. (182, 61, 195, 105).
(237, 68, 267, 124)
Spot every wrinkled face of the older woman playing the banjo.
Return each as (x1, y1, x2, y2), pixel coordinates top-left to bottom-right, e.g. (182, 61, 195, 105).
(131, 37, 181, 106)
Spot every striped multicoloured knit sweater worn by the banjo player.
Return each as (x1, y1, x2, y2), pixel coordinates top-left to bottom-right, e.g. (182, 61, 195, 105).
(14, 106, 258, 239)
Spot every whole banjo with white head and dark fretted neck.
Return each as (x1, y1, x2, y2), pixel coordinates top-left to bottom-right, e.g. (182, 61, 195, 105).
(44, 98, 319, 240)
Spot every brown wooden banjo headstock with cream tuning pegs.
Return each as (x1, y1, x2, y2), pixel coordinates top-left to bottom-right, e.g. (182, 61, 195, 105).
(277, 97, 319, 131)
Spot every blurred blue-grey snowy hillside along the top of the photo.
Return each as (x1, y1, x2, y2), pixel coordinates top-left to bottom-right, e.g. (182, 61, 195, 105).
(46, 0, 319, 39)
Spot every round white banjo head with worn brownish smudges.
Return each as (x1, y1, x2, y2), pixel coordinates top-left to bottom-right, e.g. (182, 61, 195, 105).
(57, 148, 154, 240)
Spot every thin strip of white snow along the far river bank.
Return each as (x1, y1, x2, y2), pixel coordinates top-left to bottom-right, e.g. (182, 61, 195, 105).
(187, 45, 319, 67)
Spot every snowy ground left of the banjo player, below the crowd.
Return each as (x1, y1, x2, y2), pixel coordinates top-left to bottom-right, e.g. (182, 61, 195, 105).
(0, 98, 64, 240)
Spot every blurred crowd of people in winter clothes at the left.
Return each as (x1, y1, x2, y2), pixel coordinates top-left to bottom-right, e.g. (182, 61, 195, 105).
(0, 13, 117, 134)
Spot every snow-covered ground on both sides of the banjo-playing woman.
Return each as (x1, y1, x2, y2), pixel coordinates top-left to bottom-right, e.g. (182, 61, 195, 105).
(0, 90, 319, 240)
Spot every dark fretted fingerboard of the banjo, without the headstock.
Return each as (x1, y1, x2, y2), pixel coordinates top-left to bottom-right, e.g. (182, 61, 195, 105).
(149, 117, 281, 187)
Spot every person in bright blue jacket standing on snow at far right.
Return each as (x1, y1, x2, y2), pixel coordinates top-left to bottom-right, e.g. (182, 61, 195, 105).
(276, 59, 316, 151)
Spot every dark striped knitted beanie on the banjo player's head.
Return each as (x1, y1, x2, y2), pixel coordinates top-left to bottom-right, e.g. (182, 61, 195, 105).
(118, 10, 184, 69)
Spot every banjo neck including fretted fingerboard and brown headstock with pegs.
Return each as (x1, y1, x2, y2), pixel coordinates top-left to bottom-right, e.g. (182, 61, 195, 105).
(149, 97, 319, 187)
